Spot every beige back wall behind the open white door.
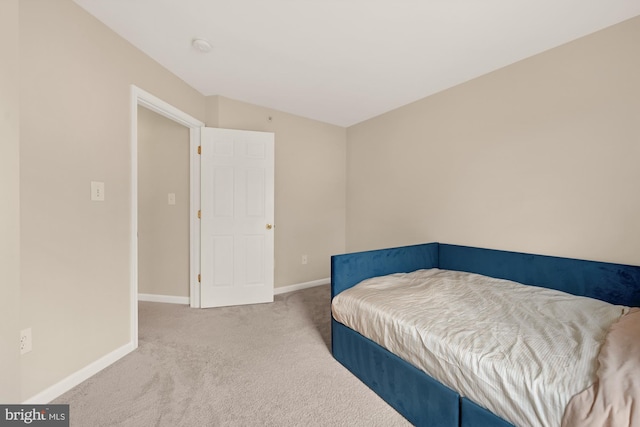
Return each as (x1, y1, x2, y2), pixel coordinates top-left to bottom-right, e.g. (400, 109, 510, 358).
(214, 97, 346, 287)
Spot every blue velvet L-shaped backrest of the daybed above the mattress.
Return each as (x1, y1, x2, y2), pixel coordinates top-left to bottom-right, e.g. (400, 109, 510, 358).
(331, 243, 640, 307)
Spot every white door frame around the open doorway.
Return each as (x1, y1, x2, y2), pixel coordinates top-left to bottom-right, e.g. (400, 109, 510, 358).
(129, 85, 205, 348)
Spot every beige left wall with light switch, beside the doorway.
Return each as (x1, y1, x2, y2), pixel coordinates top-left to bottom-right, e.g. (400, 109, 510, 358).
(19, 0, 205, 400)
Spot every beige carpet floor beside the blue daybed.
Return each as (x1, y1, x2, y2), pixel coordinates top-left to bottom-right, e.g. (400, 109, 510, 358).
(53, 285, 410, 427)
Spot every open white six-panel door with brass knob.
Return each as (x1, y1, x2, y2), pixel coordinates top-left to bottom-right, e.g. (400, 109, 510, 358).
(200, 128, 274, 308)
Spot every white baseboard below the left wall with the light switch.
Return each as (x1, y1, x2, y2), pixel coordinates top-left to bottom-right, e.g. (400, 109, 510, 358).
(23, 343, 136, 405)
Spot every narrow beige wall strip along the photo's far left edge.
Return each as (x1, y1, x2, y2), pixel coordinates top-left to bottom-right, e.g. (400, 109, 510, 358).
(0, 0, 21, 403)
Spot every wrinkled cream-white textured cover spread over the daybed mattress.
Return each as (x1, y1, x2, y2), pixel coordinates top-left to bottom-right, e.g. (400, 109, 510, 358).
(332, 269, 629, 427)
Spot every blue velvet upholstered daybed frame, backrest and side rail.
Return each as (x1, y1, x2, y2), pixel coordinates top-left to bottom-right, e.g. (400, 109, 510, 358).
(331, 243, 640, 427)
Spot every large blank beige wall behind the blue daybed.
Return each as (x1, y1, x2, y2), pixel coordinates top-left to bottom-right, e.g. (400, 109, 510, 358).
(347, 18, 640, 264)
